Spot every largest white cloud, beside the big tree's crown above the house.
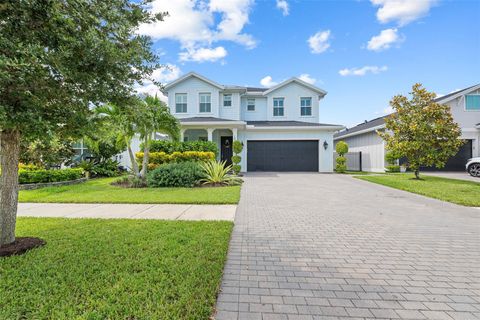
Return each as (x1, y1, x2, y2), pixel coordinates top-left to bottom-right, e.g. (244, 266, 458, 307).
(138, 0, 256, 61)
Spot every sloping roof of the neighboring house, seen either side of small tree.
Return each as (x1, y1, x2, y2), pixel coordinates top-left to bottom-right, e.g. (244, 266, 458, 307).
(333, 84, 480, 139)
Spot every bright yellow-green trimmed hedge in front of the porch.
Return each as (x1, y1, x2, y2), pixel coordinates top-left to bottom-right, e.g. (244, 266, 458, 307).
(135, 151, 215, 169)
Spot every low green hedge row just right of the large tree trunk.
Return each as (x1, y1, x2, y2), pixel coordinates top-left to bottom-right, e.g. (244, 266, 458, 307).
(18, 168, 83, 184)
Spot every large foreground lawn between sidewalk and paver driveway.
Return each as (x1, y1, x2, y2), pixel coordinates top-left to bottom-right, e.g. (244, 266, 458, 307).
(0, 218, 232, 320)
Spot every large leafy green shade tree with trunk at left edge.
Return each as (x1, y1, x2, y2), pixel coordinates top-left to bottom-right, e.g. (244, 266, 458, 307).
(0, 0, 163, 245)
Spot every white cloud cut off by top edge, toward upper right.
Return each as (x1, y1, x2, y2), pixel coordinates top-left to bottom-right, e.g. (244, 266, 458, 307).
(370, 0, 437, 26)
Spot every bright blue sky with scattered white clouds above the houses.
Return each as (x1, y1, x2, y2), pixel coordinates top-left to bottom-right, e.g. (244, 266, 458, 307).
(140, 0, 480, 126)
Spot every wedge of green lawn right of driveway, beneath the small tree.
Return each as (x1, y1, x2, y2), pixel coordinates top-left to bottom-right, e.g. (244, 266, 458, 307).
(355, 173, 480, 207)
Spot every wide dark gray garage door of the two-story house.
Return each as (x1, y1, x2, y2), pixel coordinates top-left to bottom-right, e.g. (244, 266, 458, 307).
(247, 140, 318, 171)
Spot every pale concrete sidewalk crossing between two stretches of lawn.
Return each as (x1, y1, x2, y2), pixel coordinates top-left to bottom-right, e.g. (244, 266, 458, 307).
(18, 203, 237, 221)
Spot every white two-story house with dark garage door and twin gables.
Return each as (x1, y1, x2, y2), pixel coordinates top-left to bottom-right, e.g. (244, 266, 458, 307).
(164, 72, 343, 172)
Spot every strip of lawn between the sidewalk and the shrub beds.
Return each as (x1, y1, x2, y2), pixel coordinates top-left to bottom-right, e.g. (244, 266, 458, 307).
(19, 178, 240, 204)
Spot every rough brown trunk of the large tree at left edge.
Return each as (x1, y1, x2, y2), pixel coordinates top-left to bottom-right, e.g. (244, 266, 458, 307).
(0, 130, 20, 246)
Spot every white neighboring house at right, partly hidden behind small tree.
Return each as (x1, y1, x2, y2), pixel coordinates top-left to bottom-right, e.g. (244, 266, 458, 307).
(334, 84, 480, 172)
